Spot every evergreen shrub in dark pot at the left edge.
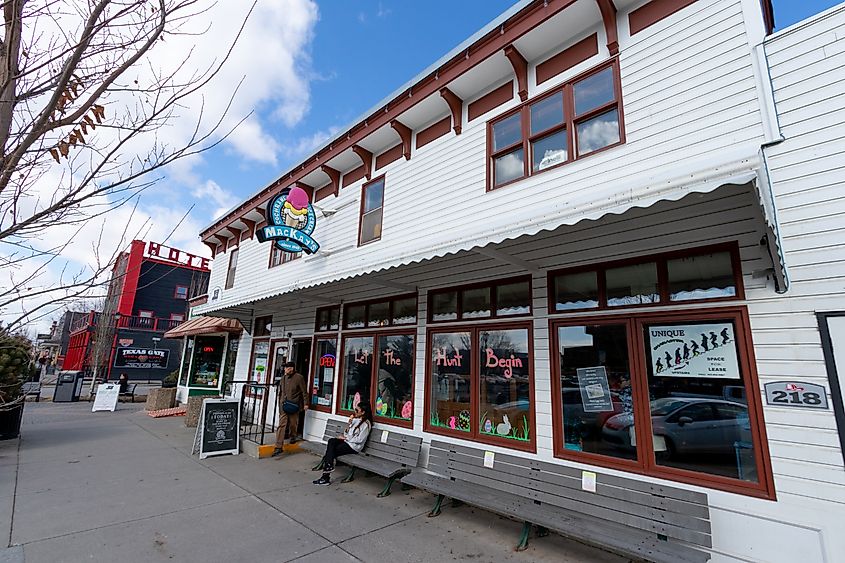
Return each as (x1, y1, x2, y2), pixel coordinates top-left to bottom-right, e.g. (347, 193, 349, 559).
(0, 331, 32, 440)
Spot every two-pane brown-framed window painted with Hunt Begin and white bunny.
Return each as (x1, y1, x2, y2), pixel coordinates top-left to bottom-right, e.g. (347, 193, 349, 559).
(424, 322, 535, 451)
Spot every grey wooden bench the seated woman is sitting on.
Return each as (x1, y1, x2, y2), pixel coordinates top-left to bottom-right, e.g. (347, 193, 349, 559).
(300, 420, 422, 497)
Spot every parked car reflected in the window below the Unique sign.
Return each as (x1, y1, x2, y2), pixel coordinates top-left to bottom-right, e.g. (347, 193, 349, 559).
(602, 397, 749, 457)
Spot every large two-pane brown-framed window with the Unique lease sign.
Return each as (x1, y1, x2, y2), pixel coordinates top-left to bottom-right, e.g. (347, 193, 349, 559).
(550, 307, 774, 498)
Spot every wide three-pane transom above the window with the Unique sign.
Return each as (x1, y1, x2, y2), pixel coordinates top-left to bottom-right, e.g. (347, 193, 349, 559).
(548, 243, 743, 313)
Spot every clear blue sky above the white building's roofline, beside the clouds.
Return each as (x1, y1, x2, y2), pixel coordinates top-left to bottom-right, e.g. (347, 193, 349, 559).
(181, 0, 836, 236)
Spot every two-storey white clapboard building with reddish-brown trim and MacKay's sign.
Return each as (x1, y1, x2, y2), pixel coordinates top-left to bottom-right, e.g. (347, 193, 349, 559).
(195, 0, 845, 562)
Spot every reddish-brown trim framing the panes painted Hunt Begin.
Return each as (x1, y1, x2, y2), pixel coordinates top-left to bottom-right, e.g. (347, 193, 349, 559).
(423, 319, 537, 454)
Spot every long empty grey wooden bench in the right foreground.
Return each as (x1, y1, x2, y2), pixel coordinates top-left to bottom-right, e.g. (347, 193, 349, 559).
(402, 441, 712, 563)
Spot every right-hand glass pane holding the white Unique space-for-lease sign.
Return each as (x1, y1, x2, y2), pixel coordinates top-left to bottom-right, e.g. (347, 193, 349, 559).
(643, 320, 757, 482)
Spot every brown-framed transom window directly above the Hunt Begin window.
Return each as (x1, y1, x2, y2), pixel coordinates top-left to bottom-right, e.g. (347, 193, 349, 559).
(428, 277, 531, 323)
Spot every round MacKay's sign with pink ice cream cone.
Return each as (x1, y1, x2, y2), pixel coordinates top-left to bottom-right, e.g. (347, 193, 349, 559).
(256, 186, 320, 254)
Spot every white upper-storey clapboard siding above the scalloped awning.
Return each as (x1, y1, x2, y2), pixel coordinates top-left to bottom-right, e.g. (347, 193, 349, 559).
(199, 0, 762, 318)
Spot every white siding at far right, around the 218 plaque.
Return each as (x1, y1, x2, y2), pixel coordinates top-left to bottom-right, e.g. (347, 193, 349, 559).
(749, 4, 845, 561)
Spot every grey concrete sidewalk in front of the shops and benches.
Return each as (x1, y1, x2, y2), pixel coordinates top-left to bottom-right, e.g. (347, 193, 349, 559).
(0, 403, 624, 563)
